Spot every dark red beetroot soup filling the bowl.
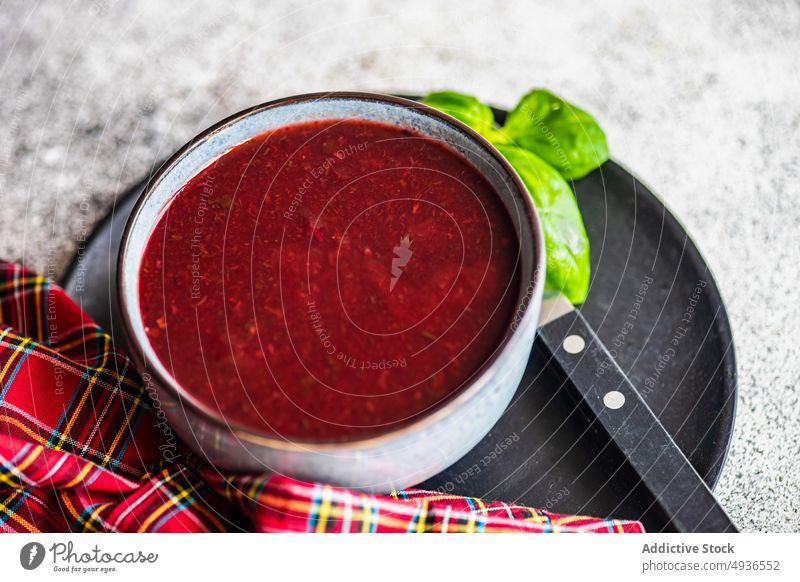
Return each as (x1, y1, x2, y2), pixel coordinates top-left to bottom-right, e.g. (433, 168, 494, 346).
(139, 120, 519, 440)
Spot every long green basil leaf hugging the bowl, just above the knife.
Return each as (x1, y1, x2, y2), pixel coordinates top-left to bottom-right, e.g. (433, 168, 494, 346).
(497, 145, 591, 303)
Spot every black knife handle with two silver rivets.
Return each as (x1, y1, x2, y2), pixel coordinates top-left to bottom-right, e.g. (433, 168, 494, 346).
(539, 310, 737, 532)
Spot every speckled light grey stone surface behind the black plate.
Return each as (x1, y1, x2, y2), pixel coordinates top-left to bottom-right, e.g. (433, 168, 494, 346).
(0, 0, 800, 531)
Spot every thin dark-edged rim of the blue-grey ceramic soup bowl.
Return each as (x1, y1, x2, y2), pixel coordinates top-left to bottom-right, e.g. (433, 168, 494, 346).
(116, 91, 545, 452)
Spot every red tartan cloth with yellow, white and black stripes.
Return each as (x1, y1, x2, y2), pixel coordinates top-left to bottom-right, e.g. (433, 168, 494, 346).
(0, 262, 643, 532)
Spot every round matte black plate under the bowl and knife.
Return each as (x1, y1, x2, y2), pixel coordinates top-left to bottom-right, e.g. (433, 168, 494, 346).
(62, 106, 736, 531)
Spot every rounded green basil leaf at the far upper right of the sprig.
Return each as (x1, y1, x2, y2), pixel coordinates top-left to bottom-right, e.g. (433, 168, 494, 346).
(502, 89, 608, 180)
